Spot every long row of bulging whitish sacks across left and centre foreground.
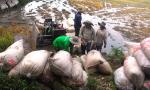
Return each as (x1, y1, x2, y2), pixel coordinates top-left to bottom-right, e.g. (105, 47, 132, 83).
(0, 39, 112, 87)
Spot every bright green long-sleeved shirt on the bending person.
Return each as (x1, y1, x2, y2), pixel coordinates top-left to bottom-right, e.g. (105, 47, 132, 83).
(53, 36, 73, 52)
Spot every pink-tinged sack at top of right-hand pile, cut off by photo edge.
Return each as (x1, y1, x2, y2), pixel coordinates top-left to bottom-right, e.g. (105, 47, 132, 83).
(141, 37, 150, 60)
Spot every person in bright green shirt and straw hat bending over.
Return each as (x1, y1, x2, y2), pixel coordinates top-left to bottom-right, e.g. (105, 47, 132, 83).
(53, 35, 80, 53)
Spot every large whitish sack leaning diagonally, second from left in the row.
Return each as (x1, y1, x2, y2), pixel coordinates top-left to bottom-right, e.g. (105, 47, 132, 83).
(9, 50, 50, 77)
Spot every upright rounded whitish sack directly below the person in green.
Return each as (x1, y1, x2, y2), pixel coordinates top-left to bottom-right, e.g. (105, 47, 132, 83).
(51, 50, 73, 77)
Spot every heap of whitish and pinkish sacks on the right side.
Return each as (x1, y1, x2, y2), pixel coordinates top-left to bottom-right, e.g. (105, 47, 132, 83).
(114, 37, 150, 90)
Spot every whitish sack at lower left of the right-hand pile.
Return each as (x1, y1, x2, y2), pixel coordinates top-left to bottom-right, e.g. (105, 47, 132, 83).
(114, 66, 134, 90)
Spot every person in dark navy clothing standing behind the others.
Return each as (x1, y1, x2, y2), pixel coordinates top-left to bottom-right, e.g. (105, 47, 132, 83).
(74, 11, 82, 36)
